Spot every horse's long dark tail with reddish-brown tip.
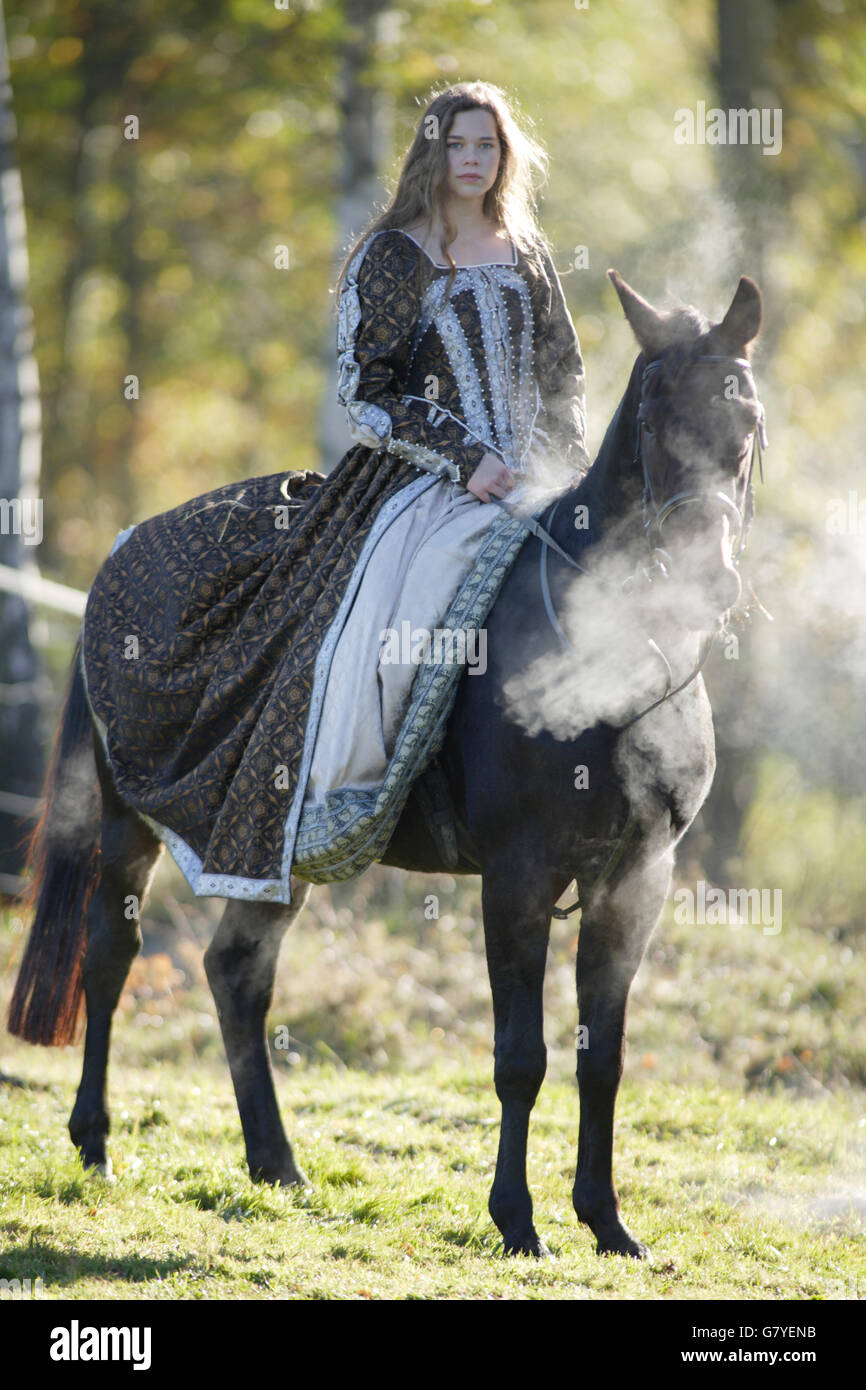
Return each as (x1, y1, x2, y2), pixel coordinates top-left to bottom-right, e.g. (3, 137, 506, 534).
(8, 637, 101, 1047)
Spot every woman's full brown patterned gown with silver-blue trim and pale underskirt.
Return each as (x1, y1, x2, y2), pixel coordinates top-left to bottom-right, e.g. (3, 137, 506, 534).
(82, 229, 588, 902)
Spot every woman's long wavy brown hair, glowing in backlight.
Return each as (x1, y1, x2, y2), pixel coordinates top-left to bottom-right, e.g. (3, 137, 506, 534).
(334, 82, 550, 297)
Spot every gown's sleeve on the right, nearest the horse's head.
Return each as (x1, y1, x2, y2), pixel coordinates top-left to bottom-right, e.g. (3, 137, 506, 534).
(534, 252, 589, 471)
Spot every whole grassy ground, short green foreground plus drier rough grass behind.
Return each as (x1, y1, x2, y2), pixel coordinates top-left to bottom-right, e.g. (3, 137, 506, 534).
(0, 870, 866, 1300)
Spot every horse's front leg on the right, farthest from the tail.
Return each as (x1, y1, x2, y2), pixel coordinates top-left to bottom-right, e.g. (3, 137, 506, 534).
(573, 855, 673, 1259)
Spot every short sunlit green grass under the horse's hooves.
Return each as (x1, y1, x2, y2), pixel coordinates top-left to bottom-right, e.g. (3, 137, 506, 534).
(0, 1045, 866, 1300)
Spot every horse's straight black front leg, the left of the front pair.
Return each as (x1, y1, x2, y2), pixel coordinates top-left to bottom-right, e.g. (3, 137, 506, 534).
(482, 859, 556, 1255)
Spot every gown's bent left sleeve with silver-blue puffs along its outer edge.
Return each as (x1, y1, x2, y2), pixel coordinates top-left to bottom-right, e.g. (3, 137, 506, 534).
(336, 231, 488, 487)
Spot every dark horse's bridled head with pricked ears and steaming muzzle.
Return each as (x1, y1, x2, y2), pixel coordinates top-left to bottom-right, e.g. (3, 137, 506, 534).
(607, 270, 766, 630)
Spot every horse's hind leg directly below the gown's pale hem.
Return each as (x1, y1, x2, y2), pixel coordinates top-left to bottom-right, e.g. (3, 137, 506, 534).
(204, 878, 310, 1187)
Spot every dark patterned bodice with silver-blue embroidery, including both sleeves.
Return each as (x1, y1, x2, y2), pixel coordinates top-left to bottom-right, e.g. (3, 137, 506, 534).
(338, 228, 588, 485)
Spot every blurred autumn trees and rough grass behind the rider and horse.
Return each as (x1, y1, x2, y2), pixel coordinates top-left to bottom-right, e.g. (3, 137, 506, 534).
(0, 0, 866, 1088)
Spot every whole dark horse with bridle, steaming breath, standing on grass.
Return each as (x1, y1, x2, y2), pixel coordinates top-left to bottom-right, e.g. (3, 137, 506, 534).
(10, 271, 763, 1257)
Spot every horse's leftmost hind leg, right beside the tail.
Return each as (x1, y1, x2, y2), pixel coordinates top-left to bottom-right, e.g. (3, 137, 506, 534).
(70, 735, 163, 1176)
